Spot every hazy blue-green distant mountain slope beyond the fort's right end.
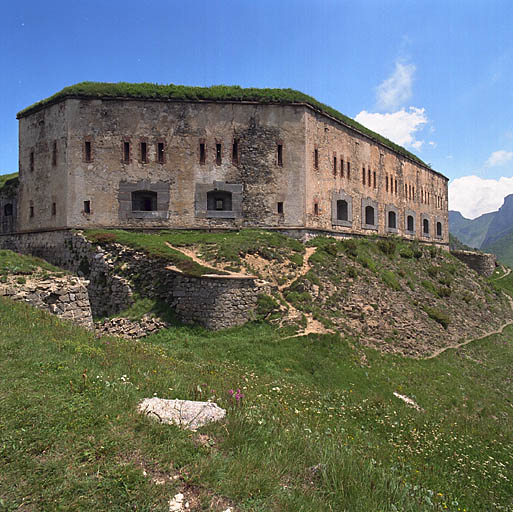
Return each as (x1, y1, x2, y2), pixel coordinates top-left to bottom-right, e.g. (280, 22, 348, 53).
(449, 194, 513, 267)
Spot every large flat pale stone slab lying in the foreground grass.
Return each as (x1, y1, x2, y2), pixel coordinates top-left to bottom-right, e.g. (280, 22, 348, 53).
(137, 397, 226, 430)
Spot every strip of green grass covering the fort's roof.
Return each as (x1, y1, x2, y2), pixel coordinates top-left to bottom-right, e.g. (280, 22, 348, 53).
(17, 82, 429, 167)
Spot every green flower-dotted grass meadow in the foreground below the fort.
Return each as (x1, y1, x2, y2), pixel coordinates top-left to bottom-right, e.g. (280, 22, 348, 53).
(0, 298, 513, 512)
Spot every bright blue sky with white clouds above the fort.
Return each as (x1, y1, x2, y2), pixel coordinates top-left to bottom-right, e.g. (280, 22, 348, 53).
(0, 0, 513, 216)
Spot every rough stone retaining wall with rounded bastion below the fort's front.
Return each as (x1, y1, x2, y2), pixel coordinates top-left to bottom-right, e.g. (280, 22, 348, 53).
(0, 230, 270, 329)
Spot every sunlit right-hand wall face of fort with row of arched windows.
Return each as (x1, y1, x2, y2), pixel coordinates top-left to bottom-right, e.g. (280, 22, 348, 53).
(306, 110, 449, 243)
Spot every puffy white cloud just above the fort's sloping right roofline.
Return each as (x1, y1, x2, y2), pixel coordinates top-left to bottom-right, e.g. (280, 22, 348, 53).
(355, 107, 428, 149)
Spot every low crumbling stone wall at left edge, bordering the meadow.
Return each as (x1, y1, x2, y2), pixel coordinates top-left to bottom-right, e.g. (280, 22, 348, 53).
(0, 276, 93, 328)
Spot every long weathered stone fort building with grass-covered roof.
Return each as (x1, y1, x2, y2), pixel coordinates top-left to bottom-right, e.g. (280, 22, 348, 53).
(0, 82, 449, 245)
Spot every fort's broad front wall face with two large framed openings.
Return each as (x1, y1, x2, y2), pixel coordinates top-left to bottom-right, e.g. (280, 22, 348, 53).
(64, 99, 305, 228)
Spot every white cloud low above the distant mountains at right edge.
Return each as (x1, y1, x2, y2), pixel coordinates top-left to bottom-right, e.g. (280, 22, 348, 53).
(449, 176, 513, 219)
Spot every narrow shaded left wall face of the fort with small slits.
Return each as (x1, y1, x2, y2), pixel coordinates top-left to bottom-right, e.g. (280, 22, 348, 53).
(18, 102, 72, 231)
